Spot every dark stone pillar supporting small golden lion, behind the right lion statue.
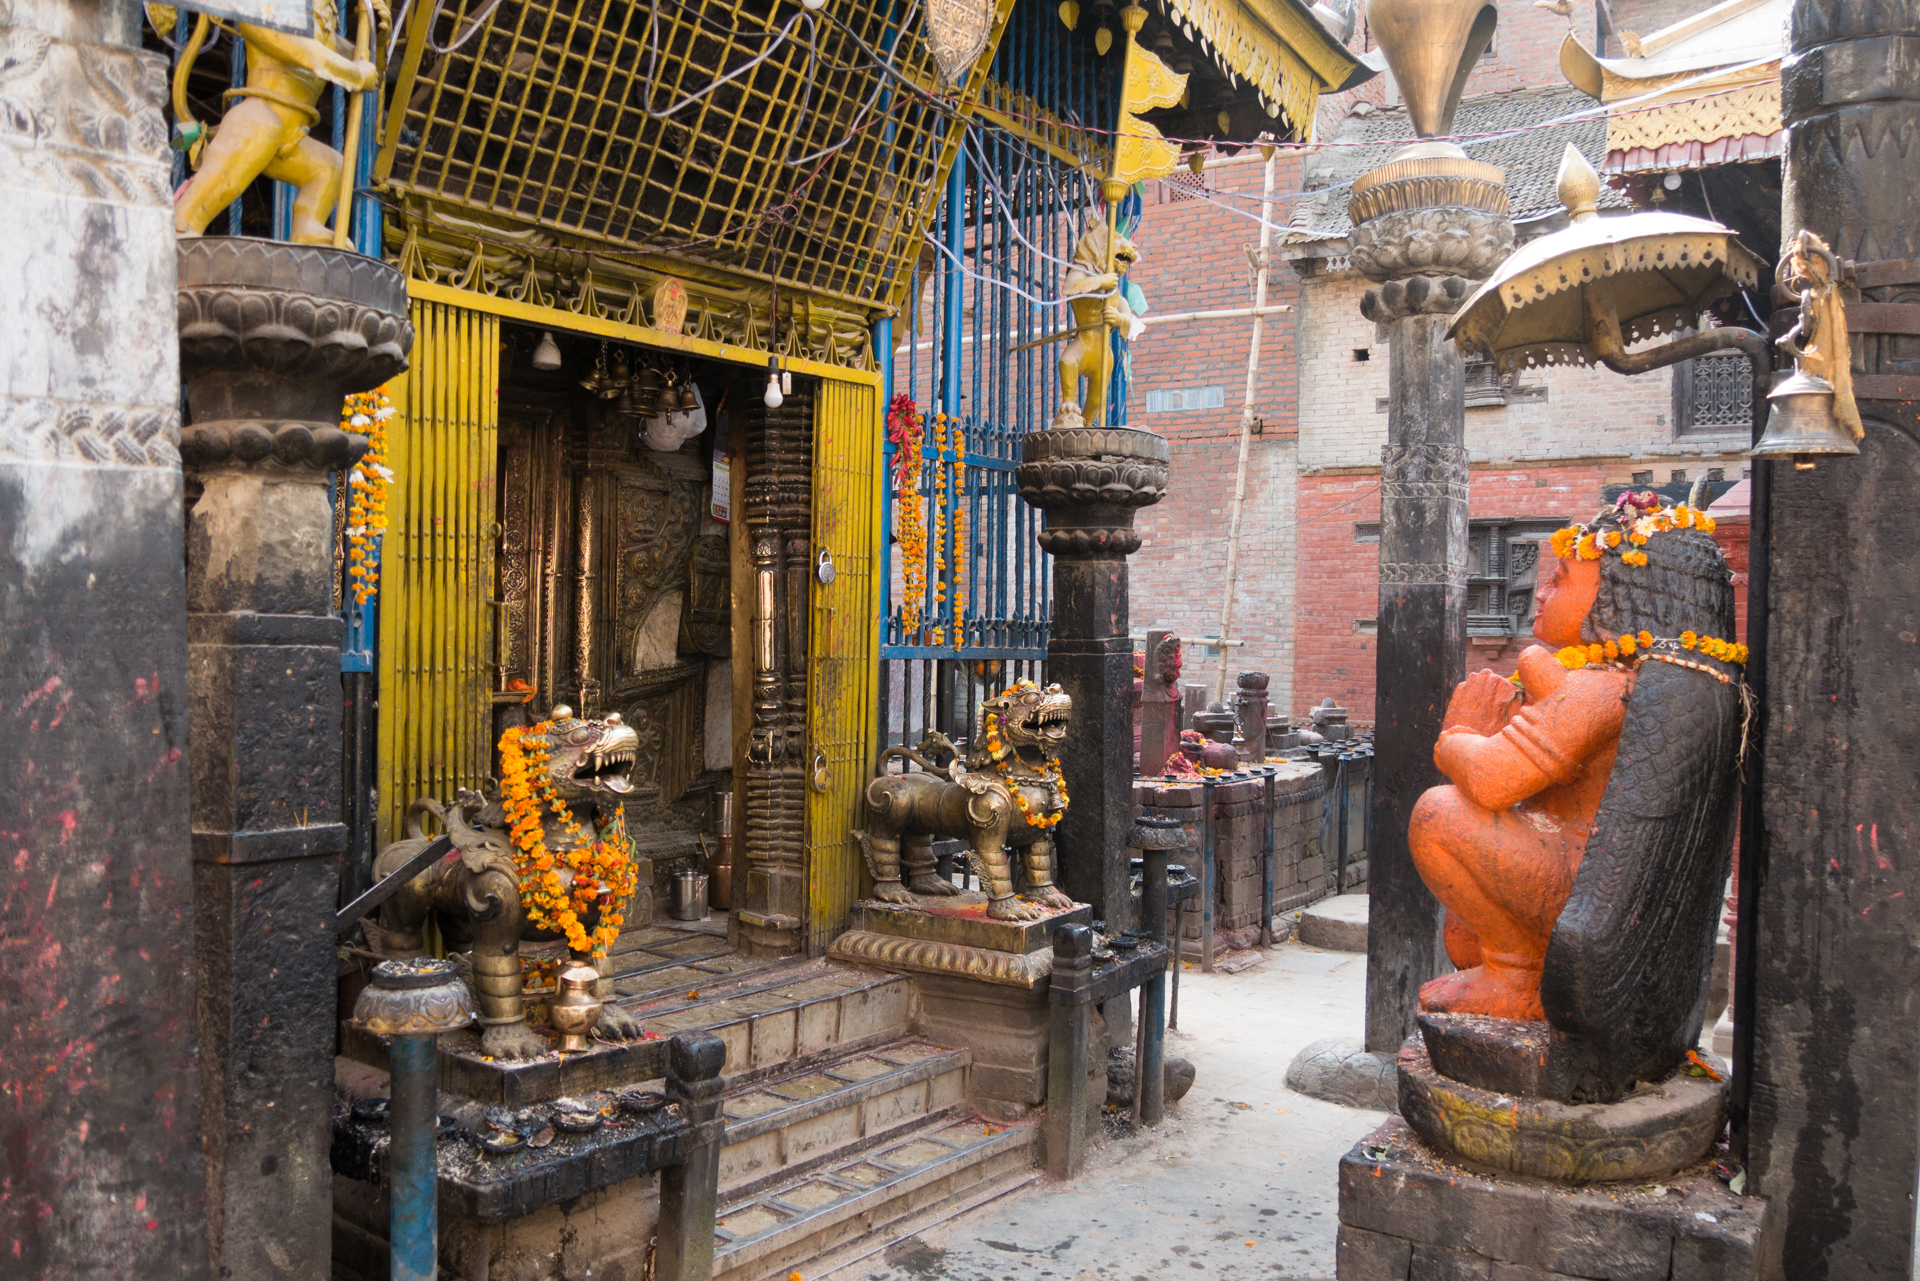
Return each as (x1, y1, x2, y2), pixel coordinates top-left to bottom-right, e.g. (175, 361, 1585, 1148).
(1014, 426, 1169, 931)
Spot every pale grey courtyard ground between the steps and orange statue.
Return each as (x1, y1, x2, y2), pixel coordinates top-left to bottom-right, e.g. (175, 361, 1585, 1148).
(804, 943, 1384, 1281)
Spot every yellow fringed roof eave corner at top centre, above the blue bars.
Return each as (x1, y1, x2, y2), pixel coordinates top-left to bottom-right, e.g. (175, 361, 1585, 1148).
(1162, 0, 1375, 140)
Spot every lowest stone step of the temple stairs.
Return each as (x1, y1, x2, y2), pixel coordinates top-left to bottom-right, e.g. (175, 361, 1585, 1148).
(712, 1120, 1041, 1281)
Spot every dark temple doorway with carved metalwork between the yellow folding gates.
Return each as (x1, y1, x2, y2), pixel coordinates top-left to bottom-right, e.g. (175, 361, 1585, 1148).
(490, 325, 744, 967)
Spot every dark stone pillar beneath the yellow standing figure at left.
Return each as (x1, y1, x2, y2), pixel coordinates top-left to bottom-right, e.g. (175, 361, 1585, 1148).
(179, 236, 413, 1281)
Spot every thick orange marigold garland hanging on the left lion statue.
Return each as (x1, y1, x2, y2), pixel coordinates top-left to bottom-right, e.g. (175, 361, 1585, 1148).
(499, 720, 639, 958)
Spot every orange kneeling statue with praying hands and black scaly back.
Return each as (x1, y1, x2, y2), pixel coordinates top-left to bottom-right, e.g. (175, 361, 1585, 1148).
(1409, 494, 1745, 1093)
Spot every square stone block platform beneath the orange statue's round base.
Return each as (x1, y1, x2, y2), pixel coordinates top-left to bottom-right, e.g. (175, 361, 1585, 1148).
(1338, 1118, 1766, 1281)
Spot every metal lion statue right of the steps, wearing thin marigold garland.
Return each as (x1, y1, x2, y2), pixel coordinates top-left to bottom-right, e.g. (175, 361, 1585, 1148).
(854, 680, 1073, 920)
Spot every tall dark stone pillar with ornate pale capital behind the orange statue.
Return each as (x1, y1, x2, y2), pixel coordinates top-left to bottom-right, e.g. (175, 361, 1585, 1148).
(1350, 163, 1513, 1054)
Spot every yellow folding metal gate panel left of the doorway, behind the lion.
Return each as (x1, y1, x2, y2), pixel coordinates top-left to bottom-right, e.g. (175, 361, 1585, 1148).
(376, 302, 499, 839)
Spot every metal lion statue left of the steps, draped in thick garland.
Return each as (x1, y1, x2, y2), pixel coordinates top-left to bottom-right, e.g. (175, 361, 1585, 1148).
(365, 707, 641, 1058)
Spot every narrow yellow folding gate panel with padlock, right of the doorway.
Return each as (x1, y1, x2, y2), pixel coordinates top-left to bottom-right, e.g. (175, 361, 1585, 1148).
(806, 380, 885, 955)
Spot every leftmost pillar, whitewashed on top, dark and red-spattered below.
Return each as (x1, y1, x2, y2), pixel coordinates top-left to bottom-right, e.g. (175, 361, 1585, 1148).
(0, 0, 207, 1279)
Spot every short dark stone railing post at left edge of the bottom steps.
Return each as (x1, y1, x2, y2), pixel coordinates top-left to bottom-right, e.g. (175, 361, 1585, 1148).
(655, 1031, 726, 1281)
